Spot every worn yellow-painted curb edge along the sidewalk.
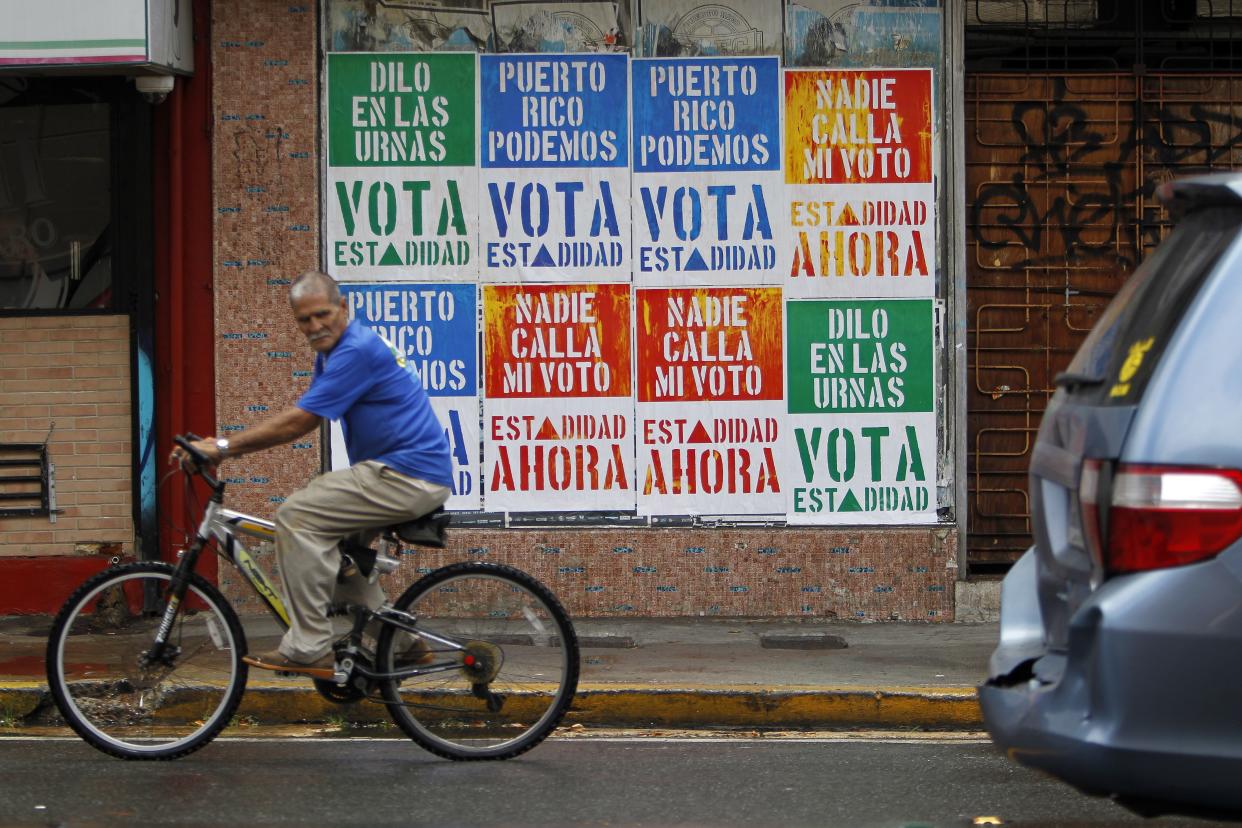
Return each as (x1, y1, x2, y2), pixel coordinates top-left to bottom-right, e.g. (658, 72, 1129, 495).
(0, 682, 982, 730)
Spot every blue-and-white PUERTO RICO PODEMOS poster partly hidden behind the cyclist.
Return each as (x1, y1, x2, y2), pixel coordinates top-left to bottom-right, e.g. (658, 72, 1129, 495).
(332, 283, 482, 510)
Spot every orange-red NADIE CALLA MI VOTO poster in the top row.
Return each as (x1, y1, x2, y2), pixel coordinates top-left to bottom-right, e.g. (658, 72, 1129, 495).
(781, 68, 935, 298)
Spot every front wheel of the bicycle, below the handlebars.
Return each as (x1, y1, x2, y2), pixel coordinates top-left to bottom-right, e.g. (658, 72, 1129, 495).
(47, 564, 246, 758)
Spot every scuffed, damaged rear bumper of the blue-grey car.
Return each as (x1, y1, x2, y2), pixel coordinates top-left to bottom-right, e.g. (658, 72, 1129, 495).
(979, 554, 1242, 809)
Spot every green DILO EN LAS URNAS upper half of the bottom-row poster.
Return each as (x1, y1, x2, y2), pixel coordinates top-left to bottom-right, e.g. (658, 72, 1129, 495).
(785, 299, 934, 413)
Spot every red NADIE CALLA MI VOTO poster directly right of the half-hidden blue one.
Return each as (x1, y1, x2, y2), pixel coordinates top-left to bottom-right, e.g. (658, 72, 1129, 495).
(483, 284, 635, 511)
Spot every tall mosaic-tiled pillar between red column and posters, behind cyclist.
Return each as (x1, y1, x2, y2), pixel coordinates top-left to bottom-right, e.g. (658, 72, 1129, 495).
(211, 0, 319, 528)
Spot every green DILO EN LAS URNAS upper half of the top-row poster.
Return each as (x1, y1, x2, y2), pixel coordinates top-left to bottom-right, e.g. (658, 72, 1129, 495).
(328, 52, 476, 166)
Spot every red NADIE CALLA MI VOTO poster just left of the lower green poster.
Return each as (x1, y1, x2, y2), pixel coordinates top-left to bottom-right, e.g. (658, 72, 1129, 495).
(635, 287, 786, 515)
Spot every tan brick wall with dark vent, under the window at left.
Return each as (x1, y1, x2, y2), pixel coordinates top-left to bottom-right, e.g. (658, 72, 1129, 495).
(0, 315, 134, 557)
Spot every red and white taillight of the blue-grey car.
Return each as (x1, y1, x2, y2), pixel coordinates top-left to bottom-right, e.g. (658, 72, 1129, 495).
(1079, 461, 1242, 572)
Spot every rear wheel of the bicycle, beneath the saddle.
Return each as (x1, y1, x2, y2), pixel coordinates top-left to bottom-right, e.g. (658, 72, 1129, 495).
(376, 562, 579, 760)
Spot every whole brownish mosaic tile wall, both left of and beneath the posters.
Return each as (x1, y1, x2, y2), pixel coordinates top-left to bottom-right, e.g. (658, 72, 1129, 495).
(211, 0, 958, 622)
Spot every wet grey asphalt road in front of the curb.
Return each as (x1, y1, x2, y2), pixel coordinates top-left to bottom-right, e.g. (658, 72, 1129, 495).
(0, 734, 1232, 828)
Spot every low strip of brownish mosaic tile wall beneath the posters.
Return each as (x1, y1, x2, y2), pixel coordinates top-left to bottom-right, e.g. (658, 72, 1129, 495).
(221, 529, 958, 622)
